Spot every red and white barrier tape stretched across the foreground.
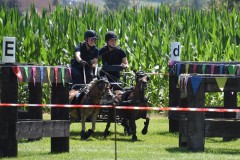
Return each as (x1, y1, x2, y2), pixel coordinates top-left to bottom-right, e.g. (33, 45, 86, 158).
(0, 103, 240, 112)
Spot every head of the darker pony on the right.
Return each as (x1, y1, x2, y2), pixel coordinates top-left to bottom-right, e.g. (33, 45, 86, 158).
(134, 71, 149, 89)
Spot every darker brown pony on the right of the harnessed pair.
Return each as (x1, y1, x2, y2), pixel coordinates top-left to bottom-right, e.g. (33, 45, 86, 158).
(103, 71, 150, 141)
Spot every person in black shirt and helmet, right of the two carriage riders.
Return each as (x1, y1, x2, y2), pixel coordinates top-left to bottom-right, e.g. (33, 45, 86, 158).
(99, 31, 128, 82)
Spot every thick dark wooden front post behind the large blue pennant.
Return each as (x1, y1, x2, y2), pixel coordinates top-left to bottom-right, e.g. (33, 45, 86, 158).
(187, 78, 205, 152)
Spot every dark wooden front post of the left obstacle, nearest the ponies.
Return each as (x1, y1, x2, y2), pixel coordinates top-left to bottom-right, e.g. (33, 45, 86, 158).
(51, 83, 69, 153)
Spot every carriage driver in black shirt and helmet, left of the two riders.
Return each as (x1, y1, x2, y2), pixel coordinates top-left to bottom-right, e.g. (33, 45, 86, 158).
(71, 30, 98, 84)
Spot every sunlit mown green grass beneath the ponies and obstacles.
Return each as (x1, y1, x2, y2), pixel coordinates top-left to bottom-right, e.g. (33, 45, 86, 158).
(4, 115, 240, 160)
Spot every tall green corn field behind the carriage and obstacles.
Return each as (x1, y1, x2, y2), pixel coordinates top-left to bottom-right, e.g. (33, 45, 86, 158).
(0, 4, 240, 106)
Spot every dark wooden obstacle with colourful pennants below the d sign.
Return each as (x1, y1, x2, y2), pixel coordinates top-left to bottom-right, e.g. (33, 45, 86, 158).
(169, 62, 240, 151)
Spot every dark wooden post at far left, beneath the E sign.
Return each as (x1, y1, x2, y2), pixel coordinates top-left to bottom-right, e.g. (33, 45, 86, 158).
(0, 67, 18, 157)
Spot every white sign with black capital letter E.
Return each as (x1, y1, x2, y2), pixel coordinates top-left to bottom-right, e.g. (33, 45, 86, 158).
(2, 37, 16, 63)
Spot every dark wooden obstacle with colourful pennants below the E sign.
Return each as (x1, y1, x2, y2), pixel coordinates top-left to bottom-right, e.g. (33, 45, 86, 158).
(0, 63, 71, 157)
